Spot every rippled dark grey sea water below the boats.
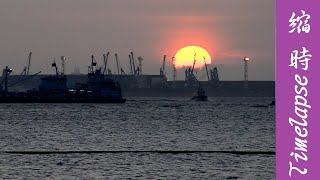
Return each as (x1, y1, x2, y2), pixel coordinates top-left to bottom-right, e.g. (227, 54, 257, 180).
(0, 97, 275, 179)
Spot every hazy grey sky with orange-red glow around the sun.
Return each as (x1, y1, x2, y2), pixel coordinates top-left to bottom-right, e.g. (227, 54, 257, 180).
(0, 0, 275, 80)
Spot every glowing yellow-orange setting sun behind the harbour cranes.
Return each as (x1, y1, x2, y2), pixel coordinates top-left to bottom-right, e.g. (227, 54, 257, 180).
(174, 46, 211, 69)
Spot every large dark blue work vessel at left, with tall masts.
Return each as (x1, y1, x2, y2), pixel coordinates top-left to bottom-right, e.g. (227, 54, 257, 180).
(0, 56, 126, 103)
